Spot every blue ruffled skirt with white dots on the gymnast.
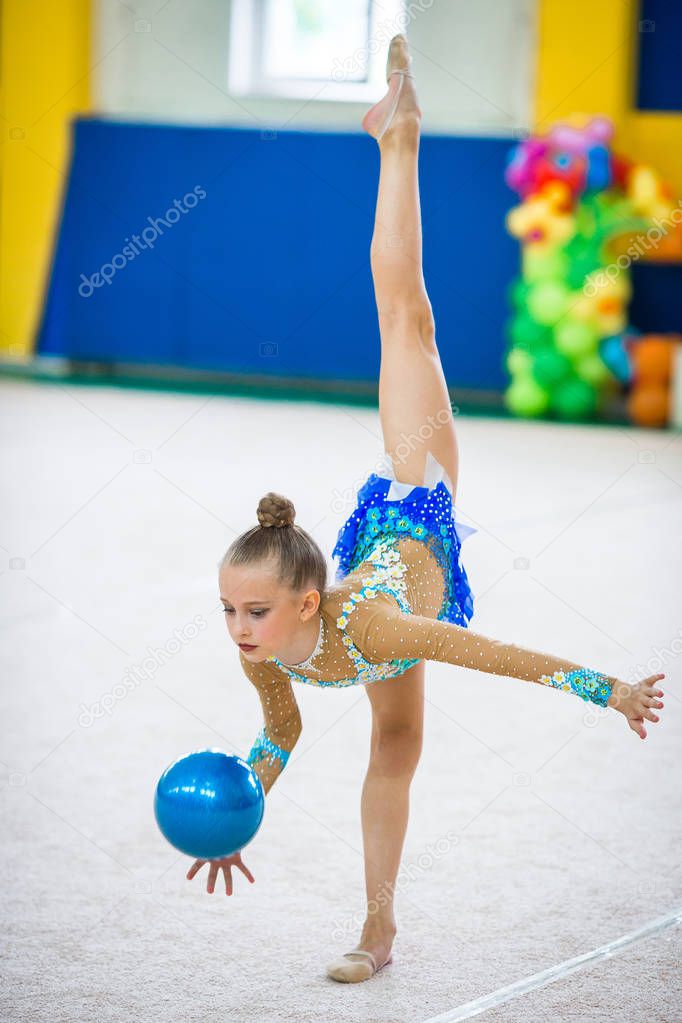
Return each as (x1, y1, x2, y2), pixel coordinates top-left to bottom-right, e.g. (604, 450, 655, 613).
(331, 452, 478, 626)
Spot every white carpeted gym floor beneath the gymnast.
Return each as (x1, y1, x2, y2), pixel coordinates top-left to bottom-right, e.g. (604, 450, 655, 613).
(0, 382, 682, 1023)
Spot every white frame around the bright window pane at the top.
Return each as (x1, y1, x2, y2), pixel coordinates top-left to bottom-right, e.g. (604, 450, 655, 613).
(227, 0, 408, 102)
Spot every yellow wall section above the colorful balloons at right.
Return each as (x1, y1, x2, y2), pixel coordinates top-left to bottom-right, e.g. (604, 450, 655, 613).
(535, 0, 682, 195)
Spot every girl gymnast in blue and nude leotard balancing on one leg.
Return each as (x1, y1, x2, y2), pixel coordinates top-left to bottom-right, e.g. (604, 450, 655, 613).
(187, 35, 665, 982)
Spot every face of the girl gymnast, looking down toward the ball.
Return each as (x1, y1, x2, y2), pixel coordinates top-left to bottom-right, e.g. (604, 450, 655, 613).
(220, 566, 319, 664)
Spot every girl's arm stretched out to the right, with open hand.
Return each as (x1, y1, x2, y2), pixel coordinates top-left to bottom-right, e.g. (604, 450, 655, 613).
(347, 592, 664, 738)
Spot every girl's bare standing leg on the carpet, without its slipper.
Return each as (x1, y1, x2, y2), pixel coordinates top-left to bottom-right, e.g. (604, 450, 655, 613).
(358, 661, 425, 966)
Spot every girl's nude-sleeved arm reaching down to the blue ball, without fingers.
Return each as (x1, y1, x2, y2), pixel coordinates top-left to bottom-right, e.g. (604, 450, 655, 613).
(239, 653, 303, 795)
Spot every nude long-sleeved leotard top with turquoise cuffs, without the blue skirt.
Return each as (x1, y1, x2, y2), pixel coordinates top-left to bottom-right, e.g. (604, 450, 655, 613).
(240, 537, 616, 792)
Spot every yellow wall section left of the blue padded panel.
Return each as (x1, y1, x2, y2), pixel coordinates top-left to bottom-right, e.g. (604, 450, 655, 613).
(0, 0, 91, 357)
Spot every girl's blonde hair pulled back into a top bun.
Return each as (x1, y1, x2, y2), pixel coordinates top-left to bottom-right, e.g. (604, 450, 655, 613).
(221, 490, 327, 594)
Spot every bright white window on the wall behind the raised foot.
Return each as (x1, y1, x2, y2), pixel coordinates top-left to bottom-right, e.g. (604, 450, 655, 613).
(228, 0, 411, 101)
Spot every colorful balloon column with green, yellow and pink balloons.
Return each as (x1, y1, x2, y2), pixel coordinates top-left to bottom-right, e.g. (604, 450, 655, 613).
(505, 117, 682, 424)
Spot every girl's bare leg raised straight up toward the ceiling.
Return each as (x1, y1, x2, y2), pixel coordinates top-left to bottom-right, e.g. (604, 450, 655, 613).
(370, 36, 459, 497)
